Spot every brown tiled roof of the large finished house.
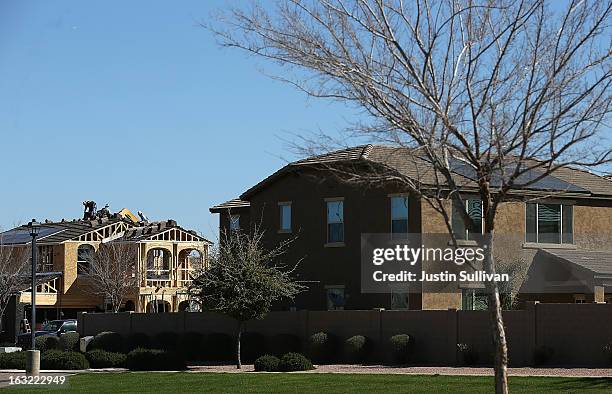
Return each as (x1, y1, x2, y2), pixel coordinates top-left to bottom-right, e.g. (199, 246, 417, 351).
(232, 144, 612, 200)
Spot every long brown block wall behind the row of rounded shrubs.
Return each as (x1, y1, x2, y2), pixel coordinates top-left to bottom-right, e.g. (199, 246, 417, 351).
(78, 303, 612, 367)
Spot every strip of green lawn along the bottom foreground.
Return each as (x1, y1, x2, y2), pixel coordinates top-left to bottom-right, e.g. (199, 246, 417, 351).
(4, 372, 612, 394)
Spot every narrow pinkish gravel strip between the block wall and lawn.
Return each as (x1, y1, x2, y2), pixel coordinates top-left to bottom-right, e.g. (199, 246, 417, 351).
(189, 364, 612, 377)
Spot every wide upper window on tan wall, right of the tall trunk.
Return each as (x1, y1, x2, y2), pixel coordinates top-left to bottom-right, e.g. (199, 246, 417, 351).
(525, 203, 574, 244)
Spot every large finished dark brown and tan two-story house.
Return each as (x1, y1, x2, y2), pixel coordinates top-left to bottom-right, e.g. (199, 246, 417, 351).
(210, 145, 612, 310)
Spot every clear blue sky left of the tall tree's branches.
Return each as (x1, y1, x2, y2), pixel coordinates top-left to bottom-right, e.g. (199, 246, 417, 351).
(0, 0, 353, 239)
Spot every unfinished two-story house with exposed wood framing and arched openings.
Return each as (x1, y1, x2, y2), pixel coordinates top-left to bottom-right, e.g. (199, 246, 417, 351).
(0, 205, 211, 330)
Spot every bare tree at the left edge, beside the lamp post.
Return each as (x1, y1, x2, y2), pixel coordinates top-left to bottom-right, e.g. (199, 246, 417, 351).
(0, 243, 32, 336)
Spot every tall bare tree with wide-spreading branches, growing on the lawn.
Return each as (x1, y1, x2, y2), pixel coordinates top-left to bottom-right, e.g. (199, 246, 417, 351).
(207, 0, 612, 393)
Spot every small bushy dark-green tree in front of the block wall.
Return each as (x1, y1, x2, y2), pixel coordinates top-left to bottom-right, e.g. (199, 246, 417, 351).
(190, 226, 304, 369)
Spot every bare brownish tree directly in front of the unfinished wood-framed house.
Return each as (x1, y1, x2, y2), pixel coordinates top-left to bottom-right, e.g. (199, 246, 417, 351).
(87, 241, 139, 313)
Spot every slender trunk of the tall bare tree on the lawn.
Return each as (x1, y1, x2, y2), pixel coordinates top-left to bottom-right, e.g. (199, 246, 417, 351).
(484, 220, 508, 394)
